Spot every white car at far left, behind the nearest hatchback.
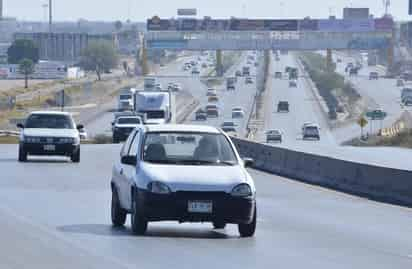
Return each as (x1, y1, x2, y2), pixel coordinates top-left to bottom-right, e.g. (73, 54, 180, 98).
(17, 111, 84, 163)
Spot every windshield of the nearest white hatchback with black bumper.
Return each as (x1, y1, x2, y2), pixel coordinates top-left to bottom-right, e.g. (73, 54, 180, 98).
(142, 132, 238, 165)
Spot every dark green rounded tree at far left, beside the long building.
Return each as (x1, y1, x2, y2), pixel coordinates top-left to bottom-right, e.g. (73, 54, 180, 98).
(7, 39, 39, 64)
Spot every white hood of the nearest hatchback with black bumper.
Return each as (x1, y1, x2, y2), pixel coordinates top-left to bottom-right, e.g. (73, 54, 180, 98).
(140, 163, 249, 193)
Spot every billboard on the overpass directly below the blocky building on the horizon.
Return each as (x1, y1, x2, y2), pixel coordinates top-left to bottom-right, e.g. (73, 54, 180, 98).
(318, 19, 375, 33)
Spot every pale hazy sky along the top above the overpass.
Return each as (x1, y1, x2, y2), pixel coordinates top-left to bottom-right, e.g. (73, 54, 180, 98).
(3, 0, 412, 21)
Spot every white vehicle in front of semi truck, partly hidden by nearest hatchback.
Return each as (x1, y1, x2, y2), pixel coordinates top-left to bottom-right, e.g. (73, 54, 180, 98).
(112, 116, 143, 144)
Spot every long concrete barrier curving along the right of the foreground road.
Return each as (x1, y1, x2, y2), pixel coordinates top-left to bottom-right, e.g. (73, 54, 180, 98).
(232, 138, 412, 206)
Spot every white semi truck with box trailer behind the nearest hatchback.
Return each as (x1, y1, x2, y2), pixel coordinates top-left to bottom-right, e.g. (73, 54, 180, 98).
(134, 90, 176, 124)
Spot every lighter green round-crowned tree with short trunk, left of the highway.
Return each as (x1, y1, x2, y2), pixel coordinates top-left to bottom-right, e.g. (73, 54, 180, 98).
(80, 41, 118, 80)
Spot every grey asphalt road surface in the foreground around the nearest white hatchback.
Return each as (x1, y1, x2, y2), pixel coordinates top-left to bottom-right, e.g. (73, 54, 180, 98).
(0, 145, 412, 269)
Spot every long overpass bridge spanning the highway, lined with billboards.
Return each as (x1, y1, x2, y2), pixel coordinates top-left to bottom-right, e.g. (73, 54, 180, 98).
(145, 17, 393, 50)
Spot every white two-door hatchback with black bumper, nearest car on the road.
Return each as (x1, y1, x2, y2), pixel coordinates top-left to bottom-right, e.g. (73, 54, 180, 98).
(111, 125, 257, 237)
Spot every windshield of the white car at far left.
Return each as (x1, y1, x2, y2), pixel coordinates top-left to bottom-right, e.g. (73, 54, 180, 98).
(25, 114, 74, 129)
